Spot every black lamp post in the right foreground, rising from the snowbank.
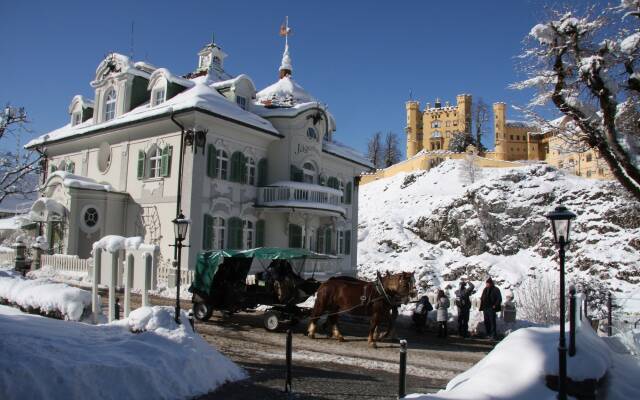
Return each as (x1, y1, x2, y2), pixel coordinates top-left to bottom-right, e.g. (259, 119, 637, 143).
(546, 206, 576, 400)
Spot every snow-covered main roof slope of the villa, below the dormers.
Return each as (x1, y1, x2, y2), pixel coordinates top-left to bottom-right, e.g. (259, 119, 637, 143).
(25, 83, 280, 148)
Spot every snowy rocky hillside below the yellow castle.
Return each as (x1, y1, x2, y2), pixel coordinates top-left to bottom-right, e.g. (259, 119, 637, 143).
(358, 160, 640, 312)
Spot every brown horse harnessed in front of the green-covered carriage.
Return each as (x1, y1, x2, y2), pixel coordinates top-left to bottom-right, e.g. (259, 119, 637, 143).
(308, 272, 415, 347)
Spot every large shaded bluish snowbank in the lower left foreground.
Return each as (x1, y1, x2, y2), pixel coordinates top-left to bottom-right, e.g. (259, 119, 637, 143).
(0, 306, 246, 400)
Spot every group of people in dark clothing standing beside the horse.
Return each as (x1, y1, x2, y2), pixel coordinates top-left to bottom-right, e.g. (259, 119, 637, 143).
(413, 278, 502, 340)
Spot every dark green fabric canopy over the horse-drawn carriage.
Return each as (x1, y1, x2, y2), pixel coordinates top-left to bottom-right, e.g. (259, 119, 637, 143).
(189, 247, 333, 293)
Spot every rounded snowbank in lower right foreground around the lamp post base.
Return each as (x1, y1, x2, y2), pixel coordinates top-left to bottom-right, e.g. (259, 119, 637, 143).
(407, 326, 640, 400)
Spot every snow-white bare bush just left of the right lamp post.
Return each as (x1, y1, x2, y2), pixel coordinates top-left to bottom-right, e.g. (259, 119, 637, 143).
(515, 276, 560, 325)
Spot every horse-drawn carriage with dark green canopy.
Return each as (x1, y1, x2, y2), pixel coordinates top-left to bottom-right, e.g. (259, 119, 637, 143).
(189, 247, 331, 331)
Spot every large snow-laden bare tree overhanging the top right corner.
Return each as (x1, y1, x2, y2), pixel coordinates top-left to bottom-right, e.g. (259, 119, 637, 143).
(512, 4, 640, 199)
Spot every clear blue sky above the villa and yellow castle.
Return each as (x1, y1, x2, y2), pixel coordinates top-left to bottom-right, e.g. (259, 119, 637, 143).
(0, 0, 596, 155)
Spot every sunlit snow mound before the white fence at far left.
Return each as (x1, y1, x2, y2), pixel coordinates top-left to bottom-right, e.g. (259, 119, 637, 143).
(0, 270, 91, 321)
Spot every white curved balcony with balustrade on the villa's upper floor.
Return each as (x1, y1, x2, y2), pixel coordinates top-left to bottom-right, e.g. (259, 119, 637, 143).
(256, 181, 346, 215)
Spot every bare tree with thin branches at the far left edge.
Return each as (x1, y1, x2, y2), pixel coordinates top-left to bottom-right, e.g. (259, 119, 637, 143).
(0, 105, 41, 202)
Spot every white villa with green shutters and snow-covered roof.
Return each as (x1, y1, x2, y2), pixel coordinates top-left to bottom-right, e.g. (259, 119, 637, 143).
(26, 33, 372, 282)
